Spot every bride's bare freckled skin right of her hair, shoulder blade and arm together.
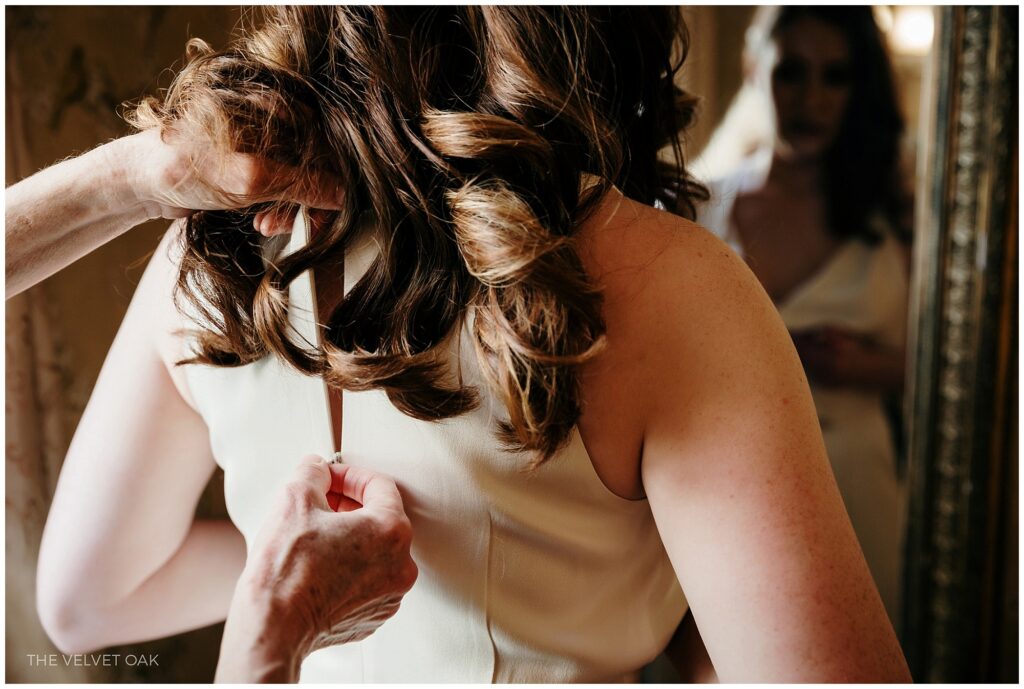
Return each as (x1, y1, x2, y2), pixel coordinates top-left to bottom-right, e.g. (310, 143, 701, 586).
(580, 191, 910, 682)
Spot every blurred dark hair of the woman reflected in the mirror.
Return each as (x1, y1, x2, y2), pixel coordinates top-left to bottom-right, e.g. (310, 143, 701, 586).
(770, 5, 908, 244)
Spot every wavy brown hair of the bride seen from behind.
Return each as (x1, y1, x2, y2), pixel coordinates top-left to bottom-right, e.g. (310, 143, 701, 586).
(130, 6, 705, 464)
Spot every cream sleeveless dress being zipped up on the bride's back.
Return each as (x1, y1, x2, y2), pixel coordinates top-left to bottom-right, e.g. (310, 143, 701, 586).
(186, 213, 686, 683)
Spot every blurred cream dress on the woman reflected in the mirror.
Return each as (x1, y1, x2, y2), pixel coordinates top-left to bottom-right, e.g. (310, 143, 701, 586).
(697, 153, 909, 626)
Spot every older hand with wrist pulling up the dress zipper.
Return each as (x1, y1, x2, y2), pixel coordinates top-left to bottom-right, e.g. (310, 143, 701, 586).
(216, 456, 417, 682)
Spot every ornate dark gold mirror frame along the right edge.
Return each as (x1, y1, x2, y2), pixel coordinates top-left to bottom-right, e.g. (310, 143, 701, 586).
(902, 6, 1018, 682)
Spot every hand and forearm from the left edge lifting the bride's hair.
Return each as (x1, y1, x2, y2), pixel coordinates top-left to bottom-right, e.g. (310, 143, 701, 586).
(4, 127, 343, 299)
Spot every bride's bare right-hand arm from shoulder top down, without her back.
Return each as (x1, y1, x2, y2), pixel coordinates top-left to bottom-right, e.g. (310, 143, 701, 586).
(638, 225, 910, 682)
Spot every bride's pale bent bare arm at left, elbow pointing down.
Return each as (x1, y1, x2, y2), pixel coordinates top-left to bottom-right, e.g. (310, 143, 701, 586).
(38, 224, 246, 651)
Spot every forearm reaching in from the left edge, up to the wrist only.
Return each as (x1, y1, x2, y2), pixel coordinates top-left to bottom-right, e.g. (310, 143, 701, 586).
(4, 135, 159, 299)
